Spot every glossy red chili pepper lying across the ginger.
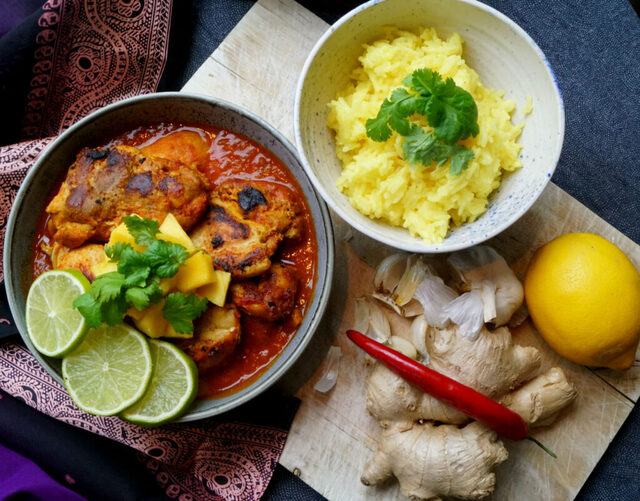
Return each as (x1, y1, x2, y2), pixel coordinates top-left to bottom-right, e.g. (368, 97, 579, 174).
(347, 330, 528, 440)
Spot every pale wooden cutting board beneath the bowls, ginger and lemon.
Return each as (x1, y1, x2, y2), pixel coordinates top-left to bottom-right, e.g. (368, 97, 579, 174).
(183, 0, 640, 501)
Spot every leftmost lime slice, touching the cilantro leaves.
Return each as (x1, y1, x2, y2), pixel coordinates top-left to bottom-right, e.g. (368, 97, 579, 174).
(26, 270, 90, 357)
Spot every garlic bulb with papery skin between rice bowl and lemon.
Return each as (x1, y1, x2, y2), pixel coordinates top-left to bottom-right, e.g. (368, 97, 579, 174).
(447, 245, 524, 326)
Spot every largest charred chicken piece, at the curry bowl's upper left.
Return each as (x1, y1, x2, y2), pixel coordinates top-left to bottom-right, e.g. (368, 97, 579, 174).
(47, 146, 207, 248)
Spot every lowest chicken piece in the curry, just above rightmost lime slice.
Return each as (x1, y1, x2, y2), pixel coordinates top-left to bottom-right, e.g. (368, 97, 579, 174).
(177, 304, 240, 373)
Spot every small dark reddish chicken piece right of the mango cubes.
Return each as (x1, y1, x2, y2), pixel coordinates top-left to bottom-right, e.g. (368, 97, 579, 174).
(230, 263, 298, 322)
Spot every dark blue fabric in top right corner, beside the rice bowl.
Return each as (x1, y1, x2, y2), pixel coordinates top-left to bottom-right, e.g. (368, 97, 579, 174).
(485, 0, 640, 243)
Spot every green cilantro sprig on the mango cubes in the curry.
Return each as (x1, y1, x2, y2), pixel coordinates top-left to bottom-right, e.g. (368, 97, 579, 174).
(73, 216, 207, 333)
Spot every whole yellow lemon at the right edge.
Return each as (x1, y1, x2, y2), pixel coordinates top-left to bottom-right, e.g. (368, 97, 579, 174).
(524, 233, 640, 369)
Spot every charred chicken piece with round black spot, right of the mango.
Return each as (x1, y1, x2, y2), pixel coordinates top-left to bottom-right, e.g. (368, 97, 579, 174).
(191, 180, 302, 278)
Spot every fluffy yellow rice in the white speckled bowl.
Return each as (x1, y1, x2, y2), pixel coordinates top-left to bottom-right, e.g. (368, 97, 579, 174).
(328, 28, 524, 243)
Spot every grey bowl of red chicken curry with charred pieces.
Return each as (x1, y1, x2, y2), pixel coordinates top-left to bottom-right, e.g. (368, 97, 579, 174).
(4, 93, 333, 421)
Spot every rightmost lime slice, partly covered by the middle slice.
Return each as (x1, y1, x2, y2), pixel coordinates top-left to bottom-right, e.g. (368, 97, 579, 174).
(121, 339, 198, 426)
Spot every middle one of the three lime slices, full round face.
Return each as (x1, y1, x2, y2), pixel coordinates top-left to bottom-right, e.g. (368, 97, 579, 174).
(62, 324, 153, 416)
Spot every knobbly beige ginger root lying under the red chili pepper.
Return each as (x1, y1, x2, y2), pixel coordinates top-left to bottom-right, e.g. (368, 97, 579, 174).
(361, 325, 576, 500)
